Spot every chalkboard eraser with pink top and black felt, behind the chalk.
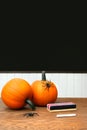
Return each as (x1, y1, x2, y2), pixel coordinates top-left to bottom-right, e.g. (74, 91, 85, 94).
(47, 102, 76, 110)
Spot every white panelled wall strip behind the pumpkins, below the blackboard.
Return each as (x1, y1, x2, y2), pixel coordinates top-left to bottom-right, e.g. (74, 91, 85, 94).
(0, 73, 87, 97)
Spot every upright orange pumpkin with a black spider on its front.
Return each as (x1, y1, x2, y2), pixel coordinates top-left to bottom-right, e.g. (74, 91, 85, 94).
(31, 71, 58, 106)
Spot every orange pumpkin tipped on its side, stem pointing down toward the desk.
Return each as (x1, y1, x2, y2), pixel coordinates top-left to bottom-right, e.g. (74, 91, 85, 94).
(1, 78, 35, 109)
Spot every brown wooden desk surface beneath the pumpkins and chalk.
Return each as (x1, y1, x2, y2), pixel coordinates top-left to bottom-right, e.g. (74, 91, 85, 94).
(0, 98, 87, 130)
